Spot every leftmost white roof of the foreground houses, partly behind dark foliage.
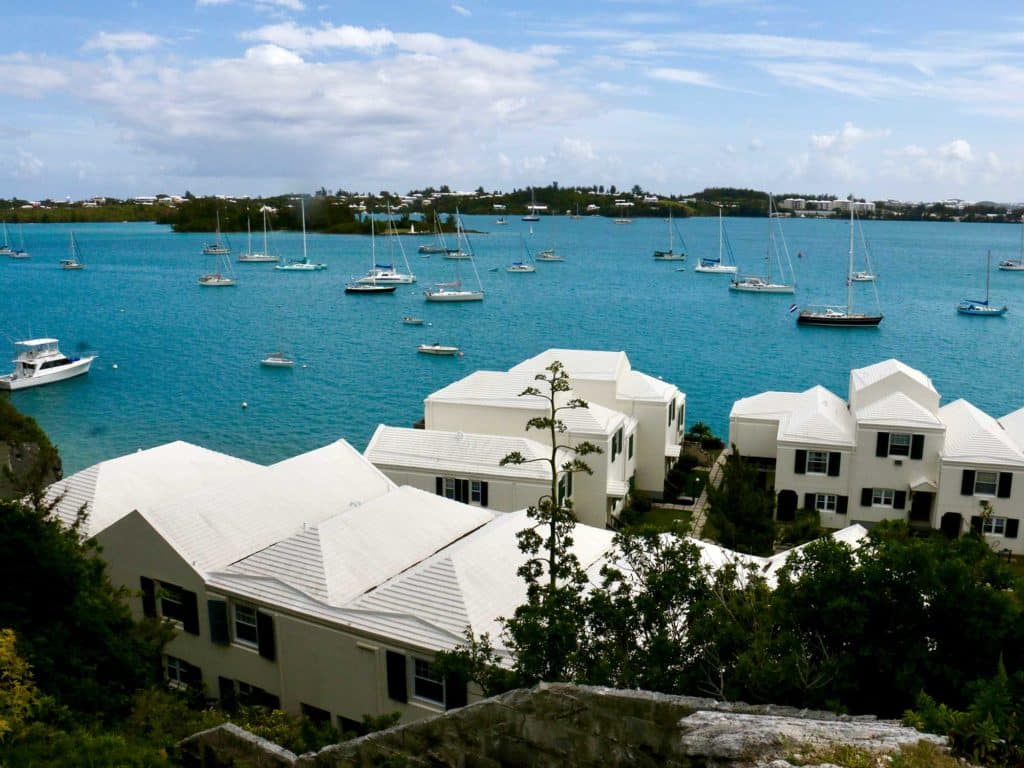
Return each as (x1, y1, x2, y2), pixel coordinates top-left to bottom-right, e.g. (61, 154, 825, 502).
(45, 440, 264, 538)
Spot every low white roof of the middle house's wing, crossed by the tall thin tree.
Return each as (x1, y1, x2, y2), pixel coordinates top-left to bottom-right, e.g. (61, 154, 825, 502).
(364, 424, 569, 481)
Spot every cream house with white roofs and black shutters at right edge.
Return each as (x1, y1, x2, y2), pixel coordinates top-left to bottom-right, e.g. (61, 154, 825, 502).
(729, 359, 1024, 553)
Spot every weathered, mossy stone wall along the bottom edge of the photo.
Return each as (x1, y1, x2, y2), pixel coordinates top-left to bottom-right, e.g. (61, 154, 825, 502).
(181, 684, 953, 768)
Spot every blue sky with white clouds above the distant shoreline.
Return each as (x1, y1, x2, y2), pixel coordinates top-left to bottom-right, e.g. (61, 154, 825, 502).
(0, 0, 1024, 202)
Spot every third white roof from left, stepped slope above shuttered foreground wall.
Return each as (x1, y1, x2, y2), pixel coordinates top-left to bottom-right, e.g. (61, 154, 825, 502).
(225, 485, 494, 606)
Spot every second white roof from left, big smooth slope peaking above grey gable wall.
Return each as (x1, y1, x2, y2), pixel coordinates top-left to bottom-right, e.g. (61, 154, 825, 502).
(140, 440, 394, 572)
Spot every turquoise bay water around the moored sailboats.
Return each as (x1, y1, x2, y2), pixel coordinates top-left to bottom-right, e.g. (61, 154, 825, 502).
(0, 216, 1024, 472)
